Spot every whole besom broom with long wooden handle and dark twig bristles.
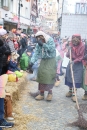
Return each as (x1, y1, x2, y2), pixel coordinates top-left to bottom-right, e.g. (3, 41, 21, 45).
(69, 48, 87, 128)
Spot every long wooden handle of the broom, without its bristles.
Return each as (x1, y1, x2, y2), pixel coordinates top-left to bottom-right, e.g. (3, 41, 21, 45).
(70, 49, 80, 110)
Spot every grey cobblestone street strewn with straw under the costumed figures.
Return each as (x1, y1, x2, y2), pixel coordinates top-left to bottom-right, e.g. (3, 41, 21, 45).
(19, 73, 86, 130)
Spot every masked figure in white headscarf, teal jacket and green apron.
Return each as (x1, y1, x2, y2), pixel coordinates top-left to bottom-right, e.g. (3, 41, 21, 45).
(30, 31, 56, 101)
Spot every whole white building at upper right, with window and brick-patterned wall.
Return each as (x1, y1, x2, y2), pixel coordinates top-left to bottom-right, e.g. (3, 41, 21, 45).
(58, 0, 87, 39)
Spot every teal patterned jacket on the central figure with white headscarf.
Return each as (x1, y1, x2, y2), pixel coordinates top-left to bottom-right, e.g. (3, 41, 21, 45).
(31, 38, 56, 63)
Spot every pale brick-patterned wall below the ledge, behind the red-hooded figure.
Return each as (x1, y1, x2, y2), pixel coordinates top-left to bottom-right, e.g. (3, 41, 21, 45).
(61, 15, 87, 38)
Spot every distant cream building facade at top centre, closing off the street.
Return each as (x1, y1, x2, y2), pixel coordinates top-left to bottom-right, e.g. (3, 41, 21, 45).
(38, 0, 58, 33)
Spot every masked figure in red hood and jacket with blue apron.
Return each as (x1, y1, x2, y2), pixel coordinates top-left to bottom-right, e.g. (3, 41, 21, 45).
(65, 35, 85, 102)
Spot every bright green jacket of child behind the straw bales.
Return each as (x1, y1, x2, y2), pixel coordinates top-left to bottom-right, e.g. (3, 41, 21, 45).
(20, 53, 30, 70)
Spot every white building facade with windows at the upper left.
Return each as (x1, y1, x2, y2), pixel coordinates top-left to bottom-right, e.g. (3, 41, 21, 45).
(0, 0, 31, 32)
